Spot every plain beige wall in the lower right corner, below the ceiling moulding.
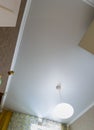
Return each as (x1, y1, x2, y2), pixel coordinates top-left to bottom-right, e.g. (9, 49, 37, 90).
(70, 106, 94, 130)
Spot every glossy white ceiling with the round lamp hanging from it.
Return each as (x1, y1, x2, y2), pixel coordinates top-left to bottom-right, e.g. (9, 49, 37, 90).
(5, 0, 94, 123)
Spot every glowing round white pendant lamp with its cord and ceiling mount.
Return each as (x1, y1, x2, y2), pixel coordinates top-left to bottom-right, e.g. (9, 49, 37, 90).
(54, 84, 74, 119)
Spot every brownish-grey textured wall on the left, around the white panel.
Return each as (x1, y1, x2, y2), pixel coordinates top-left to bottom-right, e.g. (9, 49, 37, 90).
(0, 0, 26, 94)
